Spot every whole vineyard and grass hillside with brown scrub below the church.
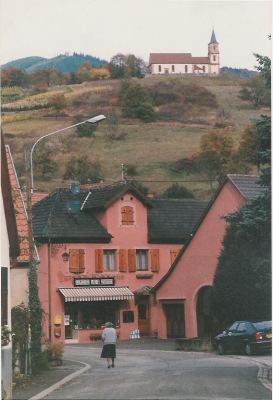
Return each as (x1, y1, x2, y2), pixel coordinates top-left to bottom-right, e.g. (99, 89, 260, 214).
(2, 76, 269, 198)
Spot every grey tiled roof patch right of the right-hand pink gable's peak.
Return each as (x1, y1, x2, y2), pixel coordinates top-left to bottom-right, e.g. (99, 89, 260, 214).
(227, 174, 265, 200)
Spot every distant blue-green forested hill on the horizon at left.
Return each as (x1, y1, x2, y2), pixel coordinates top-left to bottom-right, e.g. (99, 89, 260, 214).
(1, 53, 107, 72)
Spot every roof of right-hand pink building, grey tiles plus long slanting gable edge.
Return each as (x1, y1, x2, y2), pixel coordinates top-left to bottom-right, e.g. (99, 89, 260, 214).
(151, 174, 265, 292)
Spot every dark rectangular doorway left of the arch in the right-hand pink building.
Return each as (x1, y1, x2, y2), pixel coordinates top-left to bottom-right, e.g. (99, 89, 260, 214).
(164, 304, 185, 338)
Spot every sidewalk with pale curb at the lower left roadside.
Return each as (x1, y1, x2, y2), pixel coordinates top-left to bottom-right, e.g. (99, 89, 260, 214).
(12, 360, 84, 400)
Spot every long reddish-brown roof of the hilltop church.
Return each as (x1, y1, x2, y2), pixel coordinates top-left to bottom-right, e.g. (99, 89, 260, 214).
(149, 53, 210, 65)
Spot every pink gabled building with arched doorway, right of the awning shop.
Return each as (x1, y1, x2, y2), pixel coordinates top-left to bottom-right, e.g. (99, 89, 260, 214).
(151, 175, 264, 338)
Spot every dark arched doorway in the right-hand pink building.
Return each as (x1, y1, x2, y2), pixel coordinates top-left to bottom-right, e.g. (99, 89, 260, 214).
(196, 286, 212, 337)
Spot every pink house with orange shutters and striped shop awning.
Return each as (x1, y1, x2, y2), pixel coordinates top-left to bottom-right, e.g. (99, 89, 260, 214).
(32, 182, 208, 342)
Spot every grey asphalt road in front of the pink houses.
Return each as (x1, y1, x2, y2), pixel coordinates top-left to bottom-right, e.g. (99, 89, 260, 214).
(44, 346, 271, 400)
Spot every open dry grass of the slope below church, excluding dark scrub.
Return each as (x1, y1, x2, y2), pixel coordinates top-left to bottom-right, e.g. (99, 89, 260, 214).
(3, 77, 265, 197)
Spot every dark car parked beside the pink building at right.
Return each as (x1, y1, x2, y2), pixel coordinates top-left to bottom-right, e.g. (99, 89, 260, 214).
(215, 321, 272, 355)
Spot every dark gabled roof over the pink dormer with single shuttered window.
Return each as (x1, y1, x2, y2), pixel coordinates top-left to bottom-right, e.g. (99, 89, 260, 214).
(81, 182, 151, 210)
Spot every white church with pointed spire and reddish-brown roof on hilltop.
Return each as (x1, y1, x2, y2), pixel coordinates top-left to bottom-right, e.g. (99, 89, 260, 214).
(149, 30, 220, 75)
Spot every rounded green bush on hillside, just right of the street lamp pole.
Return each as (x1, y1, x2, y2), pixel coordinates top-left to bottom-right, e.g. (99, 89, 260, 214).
(63, 156, 102, 183)
